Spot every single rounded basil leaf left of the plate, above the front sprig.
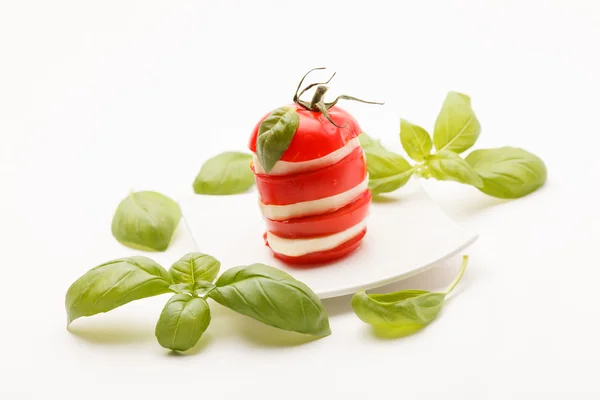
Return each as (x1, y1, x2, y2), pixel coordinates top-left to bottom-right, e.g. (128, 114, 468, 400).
(112, 192, 181, 251)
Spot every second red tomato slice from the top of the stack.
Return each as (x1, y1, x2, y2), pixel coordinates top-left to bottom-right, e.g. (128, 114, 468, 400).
(255, 147, 367, 205)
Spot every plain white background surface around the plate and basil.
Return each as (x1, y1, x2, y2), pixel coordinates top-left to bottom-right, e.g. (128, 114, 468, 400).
(0, 0, 600, 400)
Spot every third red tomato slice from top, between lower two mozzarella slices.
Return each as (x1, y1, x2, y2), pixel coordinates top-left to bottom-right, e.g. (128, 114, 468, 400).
(265, 190, 371, 239)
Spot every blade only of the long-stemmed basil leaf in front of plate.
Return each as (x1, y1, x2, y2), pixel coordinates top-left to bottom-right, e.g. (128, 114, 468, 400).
(352, 290, 445, 328)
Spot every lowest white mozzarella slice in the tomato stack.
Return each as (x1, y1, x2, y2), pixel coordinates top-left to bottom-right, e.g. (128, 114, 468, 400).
(267, 220, 367, 257)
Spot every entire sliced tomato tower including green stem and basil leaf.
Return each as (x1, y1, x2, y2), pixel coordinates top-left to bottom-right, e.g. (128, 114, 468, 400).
(249, 68, 381, 265)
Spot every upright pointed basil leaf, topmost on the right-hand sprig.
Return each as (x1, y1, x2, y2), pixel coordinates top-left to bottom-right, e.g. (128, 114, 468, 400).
(433, 92, 481, 154)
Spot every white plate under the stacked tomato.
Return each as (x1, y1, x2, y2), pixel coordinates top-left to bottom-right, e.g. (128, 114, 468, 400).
(179, 180, 477, 298)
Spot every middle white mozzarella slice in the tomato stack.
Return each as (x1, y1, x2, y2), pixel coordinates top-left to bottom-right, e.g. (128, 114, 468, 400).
(258, 174, 369, 221)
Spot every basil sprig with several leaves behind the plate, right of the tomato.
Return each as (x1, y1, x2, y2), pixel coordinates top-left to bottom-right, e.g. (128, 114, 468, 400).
(359, 92, 547, 199)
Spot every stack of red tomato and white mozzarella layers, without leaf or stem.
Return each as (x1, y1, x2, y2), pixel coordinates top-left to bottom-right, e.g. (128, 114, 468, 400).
(250, 107, 371, 265)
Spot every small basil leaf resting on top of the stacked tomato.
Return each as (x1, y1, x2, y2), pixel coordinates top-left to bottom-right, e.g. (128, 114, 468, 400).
(256, 107, 300, 172)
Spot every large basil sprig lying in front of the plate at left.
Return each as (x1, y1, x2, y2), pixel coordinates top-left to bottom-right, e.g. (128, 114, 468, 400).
(65, 253, 331, 351)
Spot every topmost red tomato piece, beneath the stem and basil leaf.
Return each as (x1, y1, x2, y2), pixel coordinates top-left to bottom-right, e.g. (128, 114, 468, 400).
(248, 104, 362, 162)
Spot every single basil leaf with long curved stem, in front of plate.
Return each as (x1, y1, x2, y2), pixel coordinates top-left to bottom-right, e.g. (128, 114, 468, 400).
(352, 256, 469, 331)
